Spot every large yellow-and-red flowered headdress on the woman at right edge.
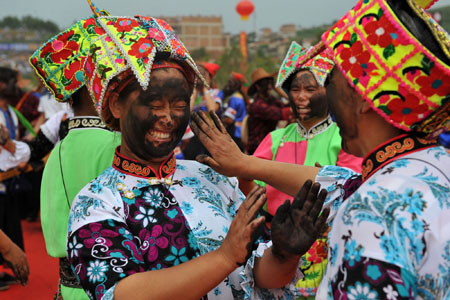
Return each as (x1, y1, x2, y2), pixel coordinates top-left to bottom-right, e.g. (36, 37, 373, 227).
(308, 0, 450, 139)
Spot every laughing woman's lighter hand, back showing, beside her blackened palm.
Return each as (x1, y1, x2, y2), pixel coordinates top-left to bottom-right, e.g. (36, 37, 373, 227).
(219, 186, 266, 267)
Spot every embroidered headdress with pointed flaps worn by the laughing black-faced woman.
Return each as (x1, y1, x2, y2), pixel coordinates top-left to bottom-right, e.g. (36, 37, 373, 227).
(80, 0, 208, 129)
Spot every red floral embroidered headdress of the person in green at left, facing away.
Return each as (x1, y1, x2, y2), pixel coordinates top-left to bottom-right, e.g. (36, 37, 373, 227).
(30, 17, 105, 102)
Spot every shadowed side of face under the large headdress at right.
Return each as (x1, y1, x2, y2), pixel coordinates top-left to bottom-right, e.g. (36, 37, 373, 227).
(325, 68, 360, 156)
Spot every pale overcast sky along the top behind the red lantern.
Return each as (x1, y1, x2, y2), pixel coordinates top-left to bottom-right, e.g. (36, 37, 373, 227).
(0, 0, 450, 33)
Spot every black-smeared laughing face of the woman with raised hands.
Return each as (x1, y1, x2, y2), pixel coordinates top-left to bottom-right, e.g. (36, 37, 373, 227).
(120, 69, 191, 161)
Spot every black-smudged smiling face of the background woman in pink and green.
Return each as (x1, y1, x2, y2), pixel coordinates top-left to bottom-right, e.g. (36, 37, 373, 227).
(289, 70, 328, 122)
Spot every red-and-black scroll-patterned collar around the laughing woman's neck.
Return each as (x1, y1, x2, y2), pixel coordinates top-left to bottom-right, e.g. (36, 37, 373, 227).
(113, 147, 177, 180)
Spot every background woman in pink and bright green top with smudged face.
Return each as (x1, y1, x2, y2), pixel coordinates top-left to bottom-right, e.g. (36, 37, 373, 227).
(246, 42, 362, 299)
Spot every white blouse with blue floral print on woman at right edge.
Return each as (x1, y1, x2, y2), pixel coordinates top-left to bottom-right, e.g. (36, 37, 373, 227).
(316, 147, 450, 299)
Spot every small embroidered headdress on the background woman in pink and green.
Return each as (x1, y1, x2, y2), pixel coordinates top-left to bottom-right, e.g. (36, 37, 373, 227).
(276, 42, 334, 91)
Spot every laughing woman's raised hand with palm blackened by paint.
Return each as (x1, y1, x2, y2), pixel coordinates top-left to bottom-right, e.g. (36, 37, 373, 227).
(271, 180, 329, 260)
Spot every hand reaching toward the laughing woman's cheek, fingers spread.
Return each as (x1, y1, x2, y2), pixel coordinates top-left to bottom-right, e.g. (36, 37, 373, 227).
(190, 111, 246, 177)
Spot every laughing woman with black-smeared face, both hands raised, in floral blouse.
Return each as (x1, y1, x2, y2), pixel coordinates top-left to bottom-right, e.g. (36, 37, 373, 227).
(67, 1, 328, 299)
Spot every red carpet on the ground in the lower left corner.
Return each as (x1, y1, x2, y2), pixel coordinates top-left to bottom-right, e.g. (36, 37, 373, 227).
(0, 221, 59, 300)
